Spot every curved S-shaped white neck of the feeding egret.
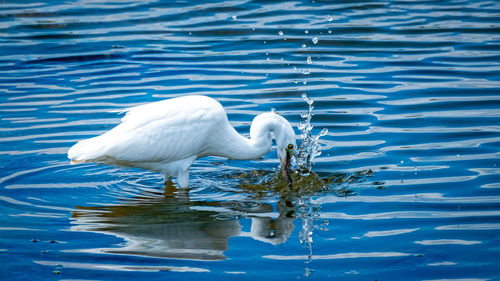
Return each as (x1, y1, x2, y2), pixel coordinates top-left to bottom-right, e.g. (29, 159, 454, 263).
(217, 113, 290, 160)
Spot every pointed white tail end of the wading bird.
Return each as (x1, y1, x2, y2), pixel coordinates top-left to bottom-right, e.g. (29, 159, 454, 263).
(68, 135, 106, 164)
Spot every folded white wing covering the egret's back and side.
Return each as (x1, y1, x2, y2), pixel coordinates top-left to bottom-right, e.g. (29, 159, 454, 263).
(102, 96, 227, 162)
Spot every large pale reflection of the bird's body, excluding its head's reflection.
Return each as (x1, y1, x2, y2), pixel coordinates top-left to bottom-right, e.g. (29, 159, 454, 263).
(72, 185, 241, 260)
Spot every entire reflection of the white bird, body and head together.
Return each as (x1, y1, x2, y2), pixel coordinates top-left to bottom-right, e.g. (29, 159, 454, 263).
(71, 186, 295, 260)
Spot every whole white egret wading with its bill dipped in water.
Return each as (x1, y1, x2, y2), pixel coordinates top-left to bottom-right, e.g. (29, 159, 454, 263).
(68, 96, 295, 187)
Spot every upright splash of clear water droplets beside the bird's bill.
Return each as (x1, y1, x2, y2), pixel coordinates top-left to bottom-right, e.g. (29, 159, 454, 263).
(295, 93, 328, 175)
